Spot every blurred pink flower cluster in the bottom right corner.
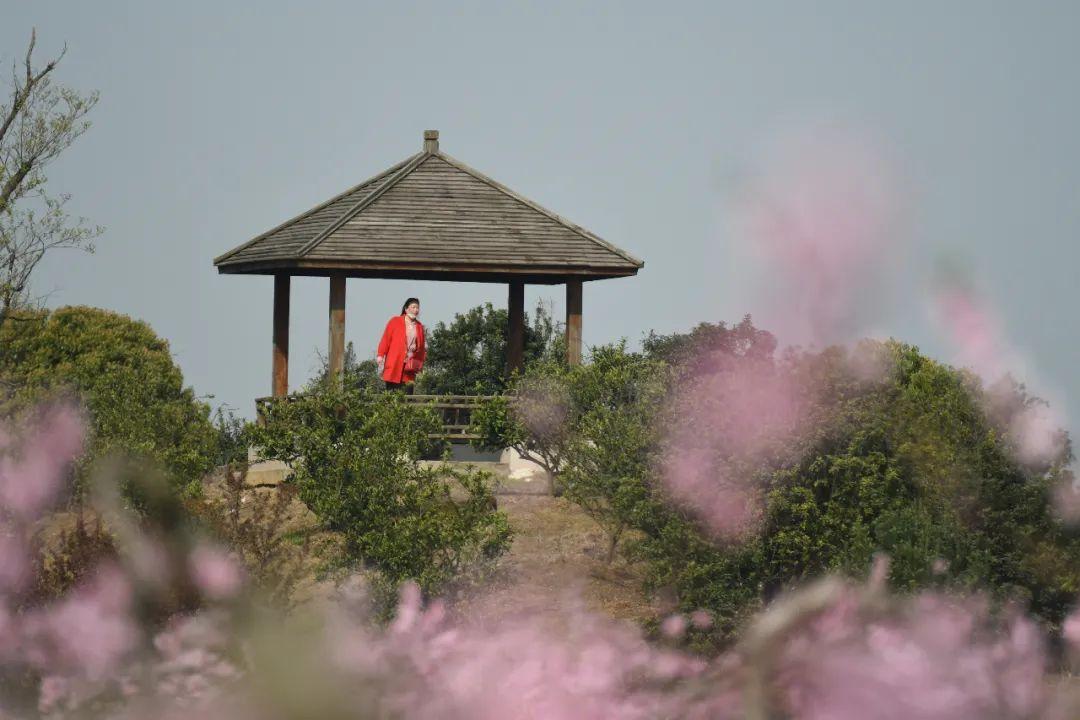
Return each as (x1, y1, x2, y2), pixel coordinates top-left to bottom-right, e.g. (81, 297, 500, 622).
(781, 596, 1047, 720)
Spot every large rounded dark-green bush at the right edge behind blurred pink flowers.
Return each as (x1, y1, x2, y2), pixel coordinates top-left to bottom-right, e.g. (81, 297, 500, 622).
(633, 342, 1080, 637)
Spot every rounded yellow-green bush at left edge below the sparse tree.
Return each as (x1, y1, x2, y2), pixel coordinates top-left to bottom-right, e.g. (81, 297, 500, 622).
(0, 307, 218, 500)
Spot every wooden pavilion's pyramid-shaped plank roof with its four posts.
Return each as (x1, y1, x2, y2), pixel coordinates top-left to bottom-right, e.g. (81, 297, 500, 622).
(214, 131, 645, 397)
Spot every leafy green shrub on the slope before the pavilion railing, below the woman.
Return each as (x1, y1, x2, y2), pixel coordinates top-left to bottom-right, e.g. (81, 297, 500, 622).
(252, 391, 510, 594)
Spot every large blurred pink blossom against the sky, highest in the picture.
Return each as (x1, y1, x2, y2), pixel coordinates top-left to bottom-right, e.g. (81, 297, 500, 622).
(733, 123, 902, 343)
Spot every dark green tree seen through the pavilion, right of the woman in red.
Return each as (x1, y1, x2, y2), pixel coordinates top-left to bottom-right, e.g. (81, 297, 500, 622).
(417, 302, 566, 395)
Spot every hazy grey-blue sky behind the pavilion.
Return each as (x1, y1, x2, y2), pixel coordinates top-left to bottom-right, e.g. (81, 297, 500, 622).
(0, 0, 1080, 423)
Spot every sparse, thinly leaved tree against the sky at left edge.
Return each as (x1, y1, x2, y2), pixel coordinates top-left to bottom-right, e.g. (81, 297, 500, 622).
(0, 32, 102, 323)
